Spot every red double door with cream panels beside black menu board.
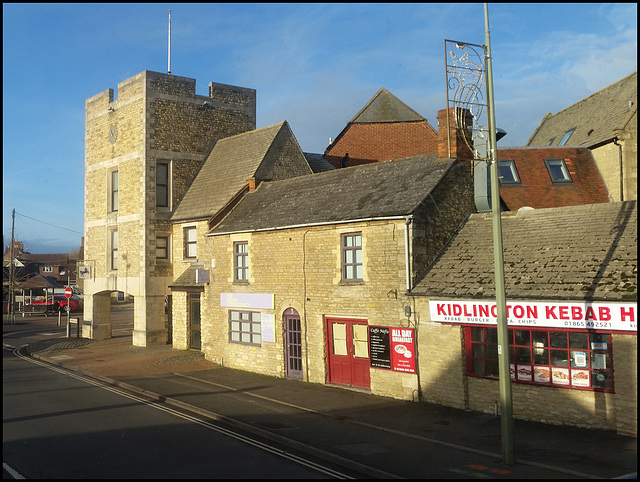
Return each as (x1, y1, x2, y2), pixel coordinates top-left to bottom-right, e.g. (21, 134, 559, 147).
(326, 318, 371, 388)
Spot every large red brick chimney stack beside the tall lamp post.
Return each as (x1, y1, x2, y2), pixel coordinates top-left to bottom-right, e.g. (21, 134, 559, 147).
(438, 107, 474, 161)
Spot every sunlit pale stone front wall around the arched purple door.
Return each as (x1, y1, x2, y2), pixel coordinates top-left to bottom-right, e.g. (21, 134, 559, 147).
(190, 220, 418, 400)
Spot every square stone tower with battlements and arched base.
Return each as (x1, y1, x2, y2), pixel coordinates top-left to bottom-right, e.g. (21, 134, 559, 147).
(83, 71, 256, 346)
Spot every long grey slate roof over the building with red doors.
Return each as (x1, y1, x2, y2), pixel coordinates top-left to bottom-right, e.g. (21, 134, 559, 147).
(210, 153, 454, 235)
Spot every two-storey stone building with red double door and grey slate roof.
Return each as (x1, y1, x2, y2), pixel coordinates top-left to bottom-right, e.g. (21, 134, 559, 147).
(172, 146, 473, 399)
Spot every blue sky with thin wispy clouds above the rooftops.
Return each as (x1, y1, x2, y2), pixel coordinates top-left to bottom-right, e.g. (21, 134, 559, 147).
(2, 3, 637, 253)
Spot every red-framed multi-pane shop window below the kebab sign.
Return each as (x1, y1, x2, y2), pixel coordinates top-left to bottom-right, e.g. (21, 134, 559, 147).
(465, 327, 613, 392)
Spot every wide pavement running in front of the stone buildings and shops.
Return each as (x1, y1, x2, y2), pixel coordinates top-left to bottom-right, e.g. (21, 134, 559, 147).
(16, 335, 637, 479)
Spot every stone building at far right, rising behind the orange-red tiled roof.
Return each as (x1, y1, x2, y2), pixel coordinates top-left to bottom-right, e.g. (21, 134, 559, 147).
(526, 72, 638, 201)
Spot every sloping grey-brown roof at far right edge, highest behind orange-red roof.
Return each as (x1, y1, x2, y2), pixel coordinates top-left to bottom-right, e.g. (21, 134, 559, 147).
(526, 72, 638, 147)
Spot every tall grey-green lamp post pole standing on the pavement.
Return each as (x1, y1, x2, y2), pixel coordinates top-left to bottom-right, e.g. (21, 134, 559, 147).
(484, 3, 515, 465)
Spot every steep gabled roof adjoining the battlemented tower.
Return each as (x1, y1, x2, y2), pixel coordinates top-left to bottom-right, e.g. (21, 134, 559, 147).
(171, 121, 312, 221)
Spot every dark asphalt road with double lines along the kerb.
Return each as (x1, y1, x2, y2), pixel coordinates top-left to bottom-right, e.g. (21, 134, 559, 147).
(2, 313, 358, 479)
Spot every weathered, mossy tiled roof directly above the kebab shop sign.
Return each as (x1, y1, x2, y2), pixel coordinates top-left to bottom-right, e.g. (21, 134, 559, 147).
(412, 201, 638, 301)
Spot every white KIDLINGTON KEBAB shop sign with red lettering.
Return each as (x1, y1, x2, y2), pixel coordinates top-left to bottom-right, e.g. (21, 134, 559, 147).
(429, 300, 638, 332)
